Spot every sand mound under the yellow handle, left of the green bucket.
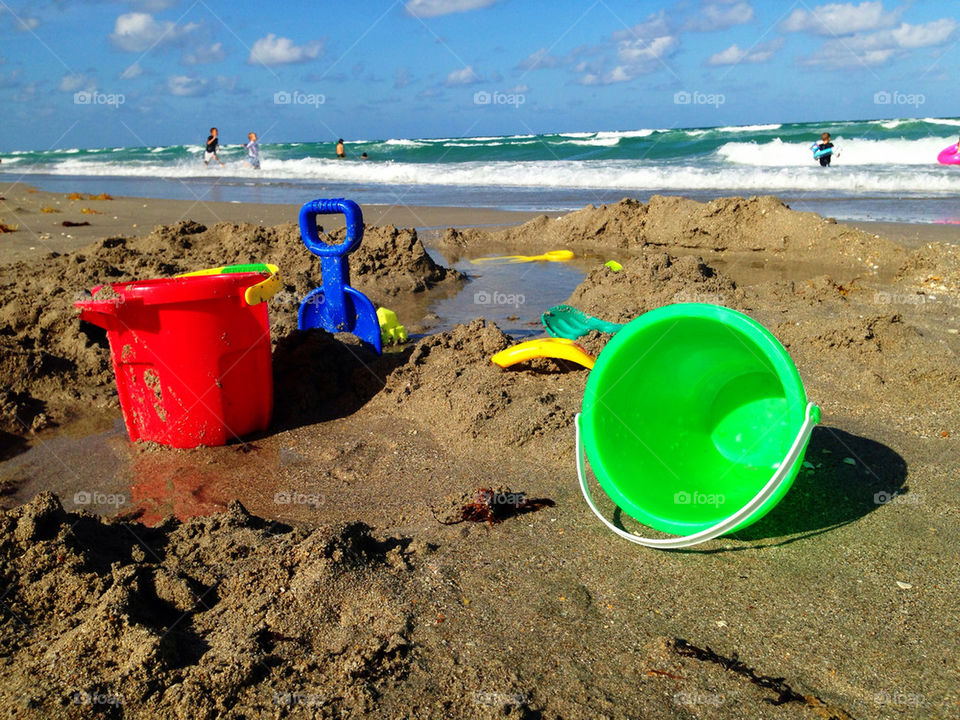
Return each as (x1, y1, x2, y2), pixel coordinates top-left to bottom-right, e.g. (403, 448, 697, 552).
(376, 320, 587, 445)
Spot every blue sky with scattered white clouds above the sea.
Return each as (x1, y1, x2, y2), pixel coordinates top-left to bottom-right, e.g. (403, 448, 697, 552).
(0, 0, 960, 151)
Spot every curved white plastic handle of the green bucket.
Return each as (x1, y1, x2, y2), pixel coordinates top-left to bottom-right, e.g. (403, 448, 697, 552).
(574, 403, 820, 550)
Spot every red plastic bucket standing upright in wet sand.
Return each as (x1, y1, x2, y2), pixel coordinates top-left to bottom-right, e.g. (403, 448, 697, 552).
(75, 273, 273, 448)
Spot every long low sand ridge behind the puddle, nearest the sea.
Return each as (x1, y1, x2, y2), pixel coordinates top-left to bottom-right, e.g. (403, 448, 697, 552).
(441, 195, 902, 266)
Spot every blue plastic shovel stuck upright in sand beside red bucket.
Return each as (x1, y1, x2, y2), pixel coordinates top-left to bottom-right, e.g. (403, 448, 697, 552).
(297, 198, 383, 353)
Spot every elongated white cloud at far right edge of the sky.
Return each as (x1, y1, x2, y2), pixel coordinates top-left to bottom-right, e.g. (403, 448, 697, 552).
(803, 18, 958, 67)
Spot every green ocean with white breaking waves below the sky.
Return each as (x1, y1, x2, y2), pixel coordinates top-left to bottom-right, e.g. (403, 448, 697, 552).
(0, 118, 960, 223)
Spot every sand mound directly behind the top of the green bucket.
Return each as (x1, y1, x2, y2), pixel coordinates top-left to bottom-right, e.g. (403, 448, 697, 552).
(567, 252, 746, 322)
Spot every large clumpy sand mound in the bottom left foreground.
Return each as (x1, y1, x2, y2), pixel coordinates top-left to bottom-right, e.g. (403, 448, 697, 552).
(0, 493, 420, 718)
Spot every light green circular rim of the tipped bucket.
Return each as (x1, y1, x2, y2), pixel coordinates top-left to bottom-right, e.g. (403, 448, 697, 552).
(581, 303, 807, 535)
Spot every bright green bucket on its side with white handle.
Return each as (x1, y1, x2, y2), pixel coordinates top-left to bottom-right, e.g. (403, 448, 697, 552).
(576, 303, 820, 548)
